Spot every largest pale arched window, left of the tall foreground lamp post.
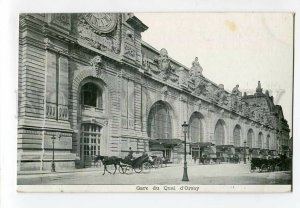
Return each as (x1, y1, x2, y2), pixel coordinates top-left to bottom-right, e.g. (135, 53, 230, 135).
(148, 102, 172, 139)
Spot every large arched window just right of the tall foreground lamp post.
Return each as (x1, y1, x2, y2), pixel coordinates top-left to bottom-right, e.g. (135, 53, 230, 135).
(189, 113, 204, 142)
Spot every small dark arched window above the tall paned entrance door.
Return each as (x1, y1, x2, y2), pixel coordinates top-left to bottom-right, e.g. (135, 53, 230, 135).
(81, 82, 103, 108)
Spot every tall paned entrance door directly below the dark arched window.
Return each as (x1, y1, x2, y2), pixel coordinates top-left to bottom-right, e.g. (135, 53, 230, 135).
(80, 123, 102, 167)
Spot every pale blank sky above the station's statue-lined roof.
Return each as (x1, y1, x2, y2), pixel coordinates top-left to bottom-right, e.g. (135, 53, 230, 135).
(135, 12, 293, 128)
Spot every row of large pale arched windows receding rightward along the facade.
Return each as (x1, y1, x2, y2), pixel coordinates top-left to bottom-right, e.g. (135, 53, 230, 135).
(148, 101, 270, 149)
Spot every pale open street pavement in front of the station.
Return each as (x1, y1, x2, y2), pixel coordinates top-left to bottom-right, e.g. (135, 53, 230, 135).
(17, 163, 292, 185)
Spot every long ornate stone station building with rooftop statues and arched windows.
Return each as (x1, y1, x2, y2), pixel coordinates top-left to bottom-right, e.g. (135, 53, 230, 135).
(18, 13, 290, 170)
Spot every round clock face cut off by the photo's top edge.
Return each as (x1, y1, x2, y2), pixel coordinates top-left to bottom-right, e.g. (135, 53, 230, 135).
(84, 13, 117, 33)
